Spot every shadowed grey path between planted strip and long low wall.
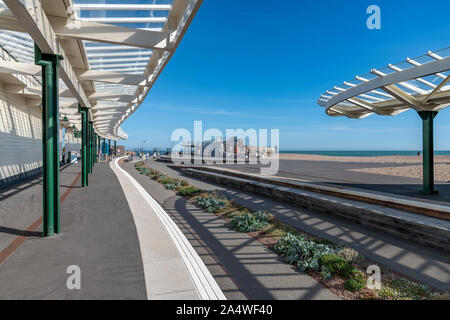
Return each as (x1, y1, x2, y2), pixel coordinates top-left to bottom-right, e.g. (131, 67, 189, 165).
(142, 161, 450, 292)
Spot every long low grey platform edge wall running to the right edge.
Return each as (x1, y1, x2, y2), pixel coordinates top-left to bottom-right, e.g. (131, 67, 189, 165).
(181, 167, 450, 252)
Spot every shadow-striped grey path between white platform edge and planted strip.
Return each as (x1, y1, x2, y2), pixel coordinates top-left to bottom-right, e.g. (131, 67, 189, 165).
(124, 162, 338, 300)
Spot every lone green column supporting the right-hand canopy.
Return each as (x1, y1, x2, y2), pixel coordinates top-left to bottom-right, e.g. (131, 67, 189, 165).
(419, 111, 438, 195)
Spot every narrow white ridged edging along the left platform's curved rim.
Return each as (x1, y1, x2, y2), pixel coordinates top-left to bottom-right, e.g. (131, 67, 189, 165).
(111, 158, 226, 300)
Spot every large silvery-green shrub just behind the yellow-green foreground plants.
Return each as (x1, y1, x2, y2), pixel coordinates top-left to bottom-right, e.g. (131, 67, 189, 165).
(274, 233, 335, 271)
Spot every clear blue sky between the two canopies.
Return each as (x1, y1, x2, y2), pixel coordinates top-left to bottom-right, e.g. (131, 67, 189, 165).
(123, 0, 450, 150)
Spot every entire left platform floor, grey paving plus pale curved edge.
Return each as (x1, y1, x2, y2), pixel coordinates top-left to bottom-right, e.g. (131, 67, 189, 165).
(0, 161, 225, 300)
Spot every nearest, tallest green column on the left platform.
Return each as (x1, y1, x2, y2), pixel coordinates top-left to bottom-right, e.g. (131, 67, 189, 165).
(34, 45, 62, 237)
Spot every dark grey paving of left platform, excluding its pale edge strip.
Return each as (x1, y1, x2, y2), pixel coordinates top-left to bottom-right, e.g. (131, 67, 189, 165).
(0, 164, 147, 299)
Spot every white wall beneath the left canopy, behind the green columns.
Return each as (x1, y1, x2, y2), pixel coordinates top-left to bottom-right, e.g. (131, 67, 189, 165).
(0, 47, 81, 189)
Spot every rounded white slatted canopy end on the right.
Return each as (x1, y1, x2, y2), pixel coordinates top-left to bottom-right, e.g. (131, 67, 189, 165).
(318, 48, 450, 119)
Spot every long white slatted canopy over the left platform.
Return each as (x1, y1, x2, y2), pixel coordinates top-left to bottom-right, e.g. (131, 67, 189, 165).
(0, 0, 202, 140)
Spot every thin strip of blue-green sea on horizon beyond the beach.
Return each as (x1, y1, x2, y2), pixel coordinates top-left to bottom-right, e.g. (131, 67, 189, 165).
(280, 150, 450, 157)
